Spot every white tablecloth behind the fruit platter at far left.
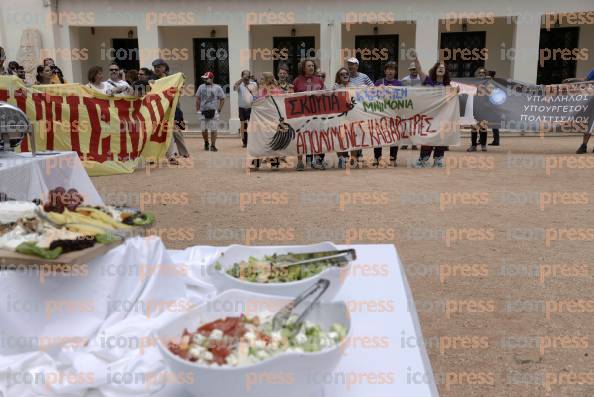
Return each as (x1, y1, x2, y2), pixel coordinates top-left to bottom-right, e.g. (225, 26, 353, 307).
(0, 152, 103, 205)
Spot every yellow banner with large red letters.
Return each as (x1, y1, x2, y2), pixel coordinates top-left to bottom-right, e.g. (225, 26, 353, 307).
(0, 73, 184, 176)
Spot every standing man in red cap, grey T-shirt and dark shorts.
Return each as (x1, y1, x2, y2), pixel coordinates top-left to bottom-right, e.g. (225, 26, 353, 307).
(196, 72, 225, 152)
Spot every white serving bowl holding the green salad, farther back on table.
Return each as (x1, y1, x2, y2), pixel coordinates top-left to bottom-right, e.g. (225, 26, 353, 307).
(207, 242, 351, 301)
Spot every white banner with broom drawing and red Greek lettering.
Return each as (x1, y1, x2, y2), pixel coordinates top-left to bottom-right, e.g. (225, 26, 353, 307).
(248, 87, 460, 157)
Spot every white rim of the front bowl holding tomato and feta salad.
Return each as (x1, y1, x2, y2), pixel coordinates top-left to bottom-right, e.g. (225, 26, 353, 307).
(157, 289, 352, 372)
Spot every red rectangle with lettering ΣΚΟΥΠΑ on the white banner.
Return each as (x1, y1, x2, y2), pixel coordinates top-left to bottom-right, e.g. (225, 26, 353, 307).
(285, 92, 350, 119)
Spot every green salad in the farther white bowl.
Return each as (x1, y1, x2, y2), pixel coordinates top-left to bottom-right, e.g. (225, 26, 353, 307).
(215, 253, 336, 283)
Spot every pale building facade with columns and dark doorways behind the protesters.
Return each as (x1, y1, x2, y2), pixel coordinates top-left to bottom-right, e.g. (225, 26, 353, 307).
(0, 0, 594, 132)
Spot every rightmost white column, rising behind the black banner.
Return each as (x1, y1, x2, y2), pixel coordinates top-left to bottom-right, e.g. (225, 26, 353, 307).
(507, 17, 540, 84)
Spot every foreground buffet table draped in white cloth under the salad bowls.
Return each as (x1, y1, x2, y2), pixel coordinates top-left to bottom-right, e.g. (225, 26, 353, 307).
(0, 238, 438, 397)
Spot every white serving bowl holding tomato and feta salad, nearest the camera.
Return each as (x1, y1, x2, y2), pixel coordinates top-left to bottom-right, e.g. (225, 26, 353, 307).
(154, 290, 351, 397)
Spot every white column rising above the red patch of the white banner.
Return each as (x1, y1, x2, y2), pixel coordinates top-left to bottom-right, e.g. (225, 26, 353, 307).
(320, 18, 343, 76)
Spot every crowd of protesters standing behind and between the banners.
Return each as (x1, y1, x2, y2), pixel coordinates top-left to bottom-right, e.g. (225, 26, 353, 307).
(0, 43, 594, 166)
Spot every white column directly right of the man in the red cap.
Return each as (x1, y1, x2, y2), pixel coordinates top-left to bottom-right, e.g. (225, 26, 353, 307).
(228, 23, 250, 134)
